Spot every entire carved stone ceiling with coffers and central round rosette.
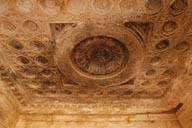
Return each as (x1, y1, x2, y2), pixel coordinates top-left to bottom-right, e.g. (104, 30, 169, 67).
(0, 0, 192, 114)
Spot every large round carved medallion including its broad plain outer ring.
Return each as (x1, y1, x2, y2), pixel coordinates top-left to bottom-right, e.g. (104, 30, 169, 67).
(55, 24, 143, 86)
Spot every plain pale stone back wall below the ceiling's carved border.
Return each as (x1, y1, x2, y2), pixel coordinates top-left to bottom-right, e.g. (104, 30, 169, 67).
(16, 114, 181, 128)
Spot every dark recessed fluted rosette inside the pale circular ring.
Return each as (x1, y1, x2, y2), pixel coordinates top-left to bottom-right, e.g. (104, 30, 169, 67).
(71, 36, 129, 75)
